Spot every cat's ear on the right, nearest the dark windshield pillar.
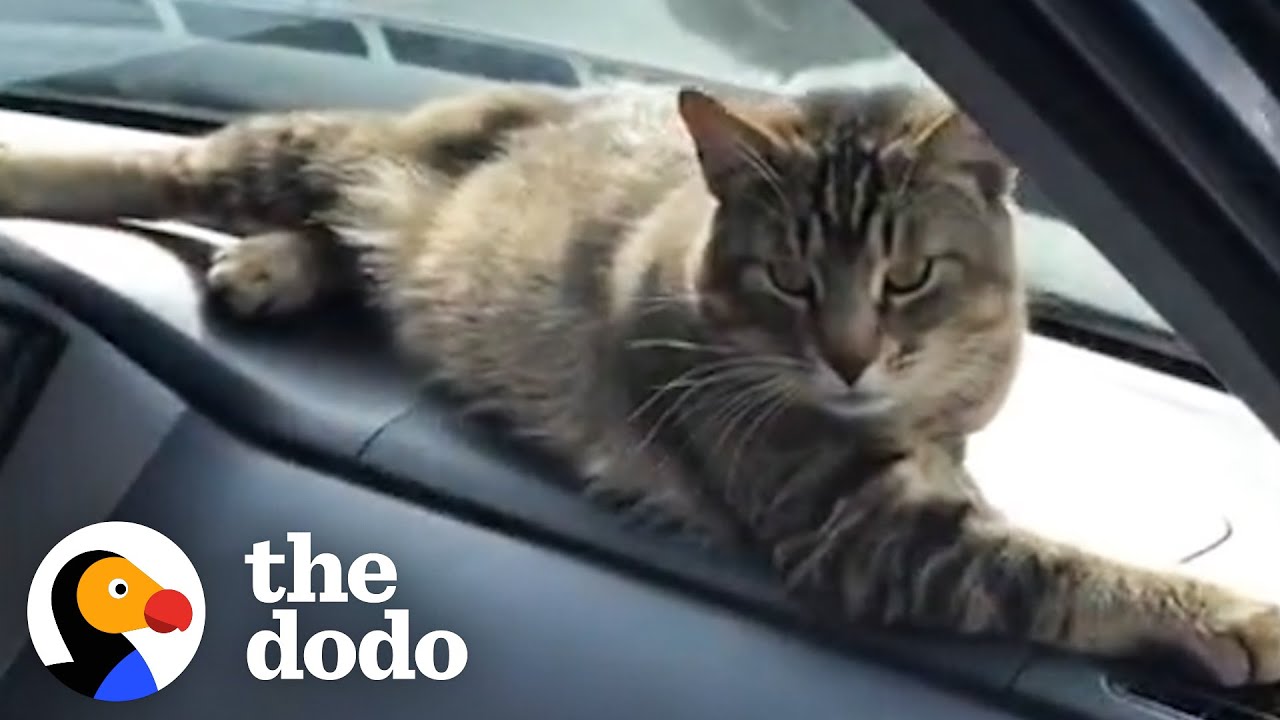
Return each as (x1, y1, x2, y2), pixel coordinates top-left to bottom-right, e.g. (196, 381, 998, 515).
(923, 111, 1018, 202)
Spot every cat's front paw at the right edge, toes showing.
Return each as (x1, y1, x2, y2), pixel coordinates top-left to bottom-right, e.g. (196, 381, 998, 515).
(1178, 596, 1280, 687)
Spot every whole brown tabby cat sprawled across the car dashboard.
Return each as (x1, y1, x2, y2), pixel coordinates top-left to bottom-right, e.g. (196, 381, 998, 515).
(0, 78, 1280, 685)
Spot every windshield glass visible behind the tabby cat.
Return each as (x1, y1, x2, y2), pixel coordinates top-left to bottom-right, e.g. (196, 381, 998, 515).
(0, 0, 1185, 352)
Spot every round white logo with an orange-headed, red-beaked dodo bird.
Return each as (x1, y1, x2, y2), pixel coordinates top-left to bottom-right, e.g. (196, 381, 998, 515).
(27, 523, 205, 702)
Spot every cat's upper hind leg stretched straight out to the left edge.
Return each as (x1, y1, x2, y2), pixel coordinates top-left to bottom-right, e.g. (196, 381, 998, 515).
(0, 113, 394, 228)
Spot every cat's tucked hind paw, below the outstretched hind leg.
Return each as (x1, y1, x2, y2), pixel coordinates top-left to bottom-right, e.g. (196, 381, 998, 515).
(206, 232, 319, 318)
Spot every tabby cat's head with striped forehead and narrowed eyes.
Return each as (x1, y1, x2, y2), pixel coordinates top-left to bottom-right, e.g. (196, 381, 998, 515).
(678, 83, 1023, 433)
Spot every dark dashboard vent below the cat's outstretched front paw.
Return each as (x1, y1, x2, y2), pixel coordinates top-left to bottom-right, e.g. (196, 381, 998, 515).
(1111, 679, 1280, 720)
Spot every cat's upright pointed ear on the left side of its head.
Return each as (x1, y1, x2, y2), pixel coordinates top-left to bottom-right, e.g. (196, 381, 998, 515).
(677, 87, 774, 197)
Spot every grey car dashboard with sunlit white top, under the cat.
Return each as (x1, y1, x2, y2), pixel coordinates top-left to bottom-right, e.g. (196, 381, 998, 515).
(0, 107, 1280, 719)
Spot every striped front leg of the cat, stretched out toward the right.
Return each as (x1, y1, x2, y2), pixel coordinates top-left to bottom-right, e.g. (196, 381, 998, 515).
(776, 453, 1280, 685)
